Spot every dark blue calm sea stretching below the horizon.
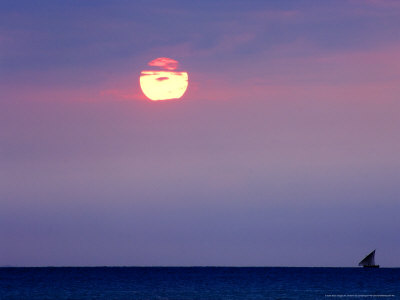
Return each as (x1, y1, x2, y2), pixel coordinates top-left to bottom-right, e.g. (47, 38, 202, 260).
(0, 267, 400, 299)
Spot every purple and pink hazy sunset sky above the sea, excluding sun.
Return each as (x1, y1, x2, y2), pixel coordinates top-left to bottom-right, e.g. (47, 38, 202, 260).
(0, 0, 400, 267)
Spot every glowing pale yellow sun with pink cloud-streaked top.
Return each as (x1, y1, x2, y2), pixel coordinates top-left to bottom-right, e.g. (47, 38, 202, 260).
(140, 57, 189, 101)
